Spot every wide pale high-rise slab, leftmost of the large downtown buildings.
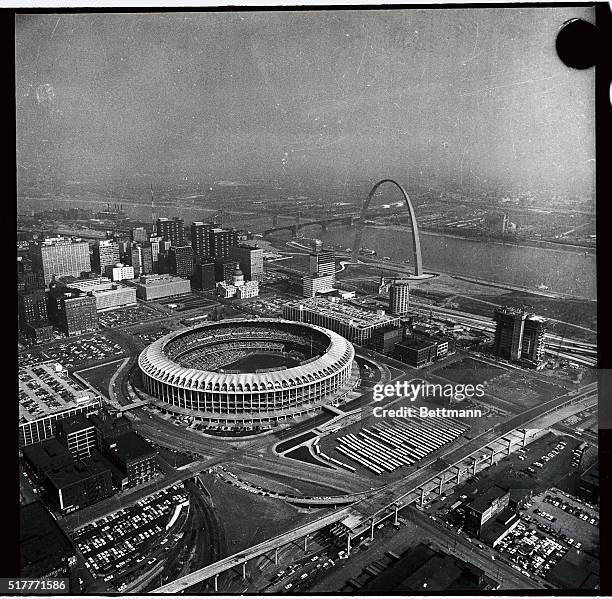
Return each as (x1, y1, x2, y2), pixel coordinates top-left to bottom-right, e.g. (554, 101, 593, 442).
(30, 237, 91, 285)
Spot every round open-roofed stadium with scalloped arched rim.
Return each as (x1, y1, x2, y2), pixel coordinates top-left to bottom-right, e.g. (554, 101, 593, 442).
(138, 319, 359, 425)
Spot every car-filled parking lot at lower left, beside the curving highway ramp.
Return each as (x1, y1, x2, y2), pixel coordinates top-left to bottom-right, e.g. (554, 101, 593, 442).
(72, 483, 189, 592)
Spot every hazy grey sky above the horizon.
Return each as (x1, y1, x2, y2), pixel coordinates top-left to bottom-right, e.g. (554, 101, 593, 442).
(16, 7, 595, 193)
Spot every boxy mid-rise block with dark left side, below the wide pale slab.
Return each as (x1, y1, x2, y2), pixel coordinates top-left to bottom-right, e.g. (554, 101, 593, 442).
(49, 285, 98, 336)
